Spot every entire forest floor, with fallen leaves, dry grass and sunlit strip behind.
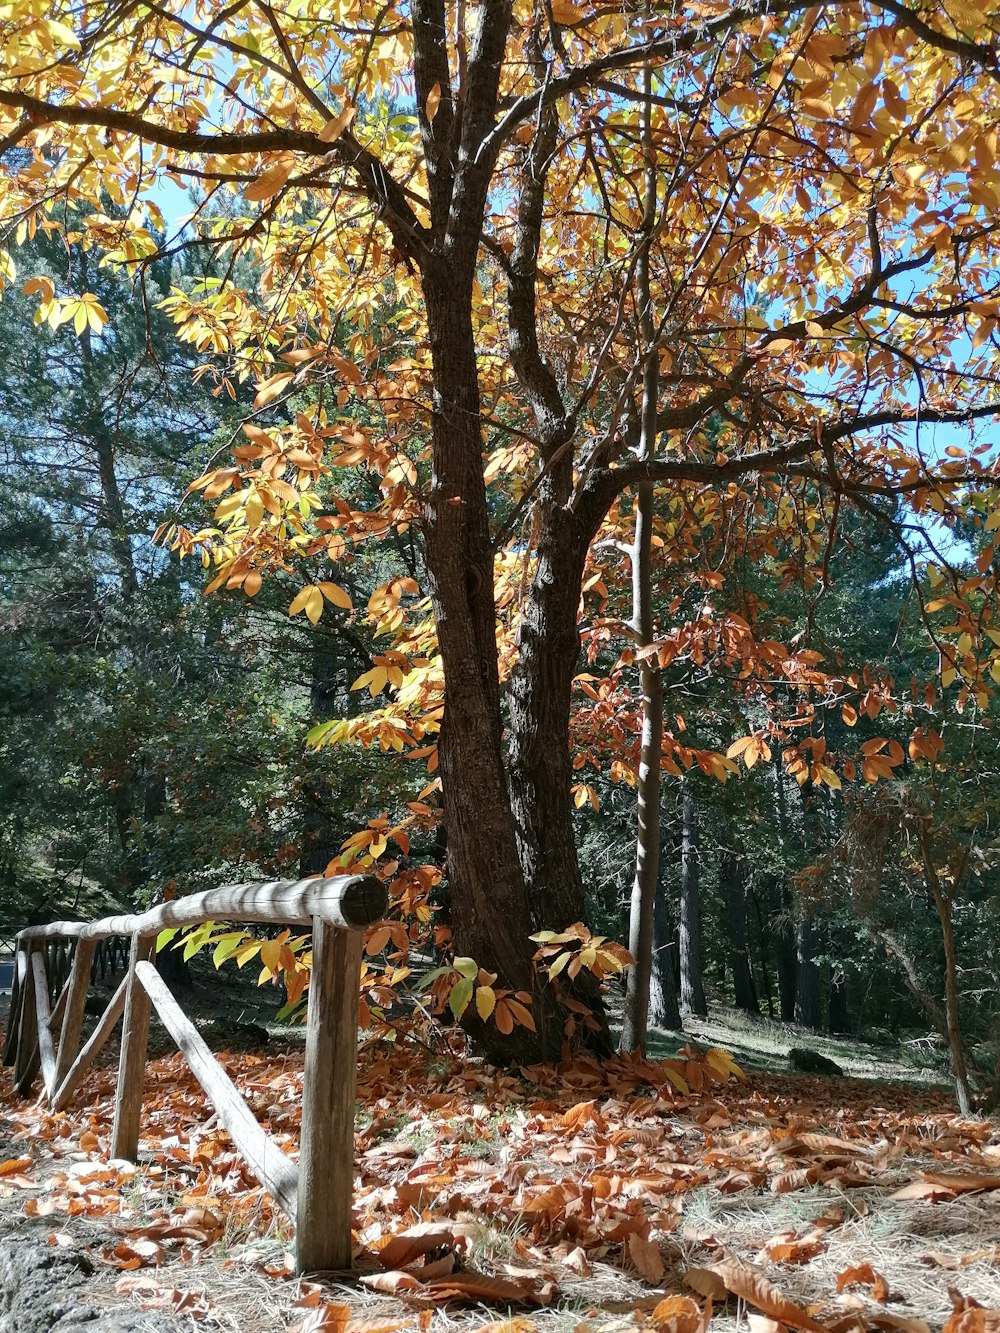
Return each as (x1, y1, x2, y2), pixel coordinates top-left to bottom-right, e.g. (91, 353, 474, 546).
(0, 980, 1000, 1333)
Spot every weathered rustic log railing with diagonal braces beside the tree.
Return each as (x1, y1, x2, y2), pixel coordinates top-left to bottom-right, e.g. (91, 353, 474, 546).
(3, 876, 385, 1273)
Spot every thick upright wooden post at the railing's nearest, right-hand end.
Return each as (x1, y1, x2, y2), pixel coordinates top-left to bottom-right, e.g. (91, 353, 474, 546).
(295, 917, 363, 1273)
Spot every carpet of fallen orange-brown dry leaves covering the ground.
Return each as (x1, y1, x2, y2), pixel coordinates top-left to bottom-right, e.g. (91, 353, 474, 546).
(0, 1046, 1000, 1333)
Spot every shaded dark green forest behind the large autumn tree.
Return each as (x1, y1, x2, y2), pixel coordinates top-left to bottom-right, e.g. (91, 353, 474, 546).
(0, 197, 1000, 1109)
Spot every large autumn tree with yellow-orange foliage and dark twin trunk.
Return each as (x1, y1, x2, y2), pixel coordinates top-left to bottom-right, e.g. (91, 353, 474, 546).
(9, 0, 1000, 1058)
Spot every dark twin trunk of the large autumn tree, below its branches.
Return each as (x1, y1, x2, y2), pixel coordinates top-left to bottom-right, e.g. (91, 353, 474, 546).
(424, 261, 611, 1062)
